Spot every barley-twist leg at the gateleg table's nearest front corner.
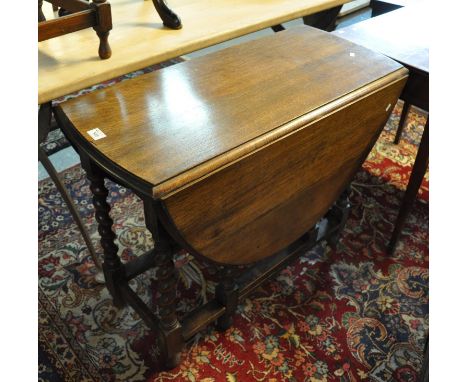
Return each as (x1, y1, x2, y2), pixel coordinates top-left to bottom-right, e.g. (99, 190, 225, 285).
(144, 199, 184, 369)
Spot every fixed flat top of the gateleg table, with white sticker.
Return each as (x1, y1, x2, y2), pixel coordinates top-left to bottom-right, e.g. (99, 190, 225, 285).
(61, 27, 401, 195)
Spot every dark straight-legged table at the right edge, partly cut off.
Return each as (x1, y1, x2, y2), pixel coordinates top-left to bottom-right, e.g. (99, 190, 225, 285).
(334, 5, 430, 252)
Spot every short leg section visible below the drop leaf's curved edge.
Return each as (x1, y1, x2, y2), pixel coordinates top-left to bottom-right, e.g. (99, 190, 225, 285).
(215, 265, 239, 331)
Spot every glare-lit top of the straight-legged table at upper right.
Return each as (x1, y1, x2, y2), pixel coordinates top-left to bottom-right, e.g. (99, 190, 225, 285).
(333, 2, 430, 73)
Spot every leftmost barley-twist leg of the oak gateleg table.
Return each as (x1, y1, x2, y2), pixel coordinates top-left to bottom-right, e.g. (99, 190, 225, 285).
(81, 158, 125, 308)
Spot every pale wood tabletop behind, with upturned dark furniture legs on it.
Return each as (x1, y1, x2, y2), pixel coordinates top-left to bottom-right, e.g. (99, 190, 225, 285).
(38, 0, 347, 103)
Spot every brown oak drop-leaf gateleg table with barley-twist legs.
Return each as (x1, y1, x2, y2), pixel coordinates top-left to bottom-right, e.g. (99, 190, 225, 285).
(56, 27, 407, 367)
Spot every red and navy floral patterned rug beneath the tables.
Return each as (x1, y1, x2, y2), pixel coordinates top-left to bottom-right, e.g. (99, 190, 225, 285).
(38, 105, 429, 382)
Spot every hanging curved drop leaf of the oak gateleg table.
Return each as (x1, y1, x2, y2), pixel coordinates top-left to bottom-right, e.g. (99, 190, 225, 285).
(164, 78, 404, 264)
